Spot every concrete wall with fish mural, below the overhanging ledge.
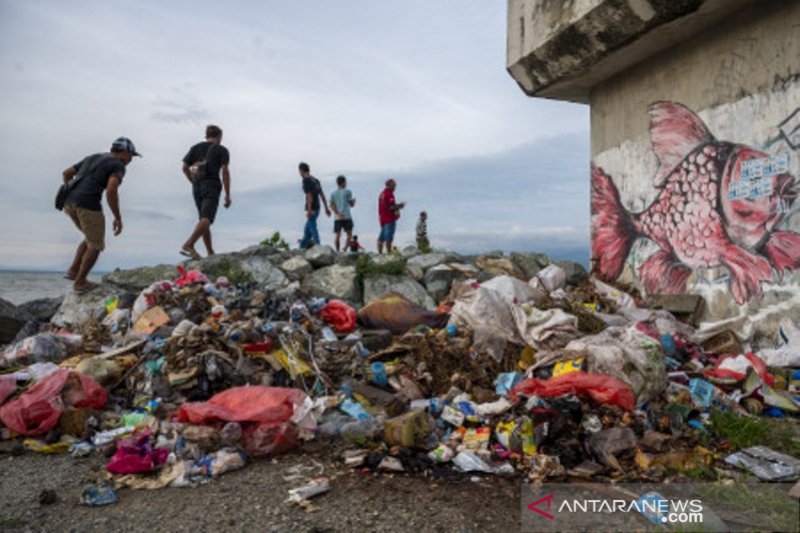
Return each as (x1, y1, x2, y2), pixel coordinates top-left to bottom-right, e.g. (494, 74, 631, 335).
(590, 0, 800, 319)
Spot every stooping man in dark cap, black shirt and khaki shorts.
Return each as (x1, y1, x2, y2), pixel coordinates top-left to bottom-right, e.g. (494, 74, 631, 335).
(63, 137, 141, 293)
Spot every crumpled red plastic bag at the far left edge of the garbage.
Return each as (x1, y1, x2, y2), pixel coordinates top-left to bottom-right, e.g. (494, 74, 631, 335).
(0, 369, 107, 436)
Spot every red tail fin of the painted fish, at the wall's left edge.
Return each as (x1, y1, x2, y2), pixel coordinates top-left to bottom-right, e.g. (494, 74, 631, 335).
(591, 163, 636, 280)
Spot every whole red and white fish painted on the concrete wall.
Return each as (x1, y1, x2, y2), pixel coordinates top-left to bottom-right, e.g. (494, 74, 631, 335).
(591, 102, 800, 304)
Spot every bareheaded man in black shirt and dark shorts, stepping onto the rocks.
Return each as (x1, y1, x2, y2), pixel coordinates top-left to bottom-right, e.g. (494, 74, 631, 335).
(180, 125, 231, 259)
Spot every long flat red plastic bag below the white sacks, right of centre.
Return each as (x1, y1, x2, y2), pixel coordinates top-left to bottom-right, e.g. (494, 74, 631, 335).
(509, 372, 635, 411)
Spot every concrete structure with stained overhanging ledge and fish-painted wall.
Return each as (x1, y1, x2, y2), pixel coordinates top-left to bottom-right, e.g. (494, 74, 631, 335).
(507, 0, 800, 333)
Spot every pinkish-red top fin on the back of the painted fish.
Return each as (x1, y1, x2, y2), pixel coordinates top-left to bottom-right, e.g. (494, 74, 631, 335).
(650, 102, 714, 187)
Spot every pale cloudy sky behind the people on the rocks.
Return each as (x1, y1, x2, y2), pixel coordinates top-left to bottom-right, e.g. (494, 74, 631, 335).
(0, 0, 589, 270)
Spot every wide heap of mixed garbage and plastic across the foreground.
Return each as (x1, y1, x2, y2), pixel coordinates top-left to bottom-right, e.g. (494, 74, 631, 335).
(0, 243, 800, 505)
